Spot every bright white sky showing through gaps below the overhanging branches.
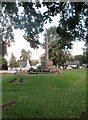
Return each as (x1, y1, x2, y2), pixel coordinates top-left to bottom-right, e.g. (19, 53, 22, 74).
(6, 11, 84, 61)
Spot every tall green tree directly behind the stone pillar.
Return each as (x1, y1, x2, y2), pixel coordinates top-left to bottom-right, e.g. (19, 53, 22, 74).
(43, 26, 72, 65)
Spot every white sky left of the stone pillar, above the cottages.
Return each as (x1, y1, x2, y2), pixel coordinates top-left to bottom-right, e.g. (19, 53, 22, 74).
(7, 30, 45, 61)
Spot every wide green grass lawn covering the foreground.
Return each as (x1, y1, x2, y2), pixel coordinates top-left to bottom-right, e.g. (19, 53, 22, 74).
(2, 69, 86, 118)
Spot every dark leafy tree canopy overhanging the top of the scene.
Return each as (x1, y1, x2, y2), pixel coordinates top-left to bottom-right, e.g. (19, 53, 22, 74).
(1, 2, 88, 52)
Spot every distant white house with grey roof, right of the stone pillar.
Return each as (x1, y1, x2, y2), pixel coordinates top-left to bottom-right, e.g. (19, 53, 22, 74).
(64, 61, 80, 69)
